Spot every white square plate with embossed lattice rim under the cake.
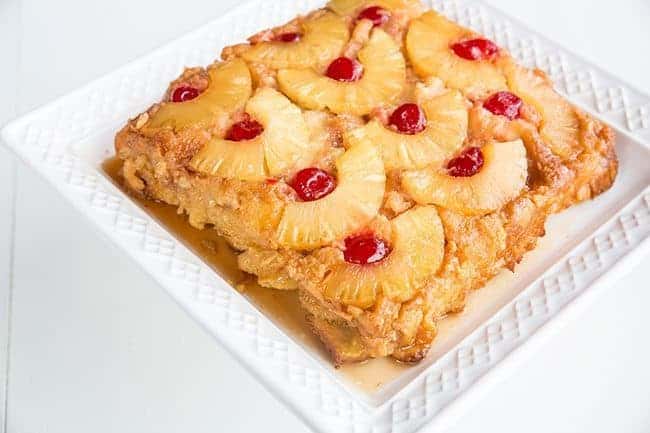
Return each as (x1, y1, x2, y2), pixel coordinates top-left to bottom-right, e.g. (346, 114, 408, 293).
(2, 0, 650, 433)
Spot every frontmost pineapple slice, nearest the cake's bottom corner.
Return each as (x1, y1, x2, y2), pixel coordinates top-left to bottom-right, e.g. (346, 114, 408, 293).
(323, 206, 445, 308)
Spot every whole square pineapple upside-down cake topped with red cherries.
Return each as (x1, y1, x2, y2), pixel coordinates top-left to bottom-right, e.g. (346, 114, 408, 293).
(115, 0, 617, 365)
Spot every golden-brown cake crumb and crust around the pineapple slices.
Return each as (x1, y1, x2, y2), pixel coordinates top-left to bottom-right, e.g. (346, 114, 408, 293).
(115, 0, 618, 365)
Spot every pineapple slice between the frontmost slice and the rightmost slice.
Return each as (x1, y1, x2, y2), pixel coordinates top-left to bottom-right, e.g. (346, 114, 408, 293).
(402, 140, 528, 215)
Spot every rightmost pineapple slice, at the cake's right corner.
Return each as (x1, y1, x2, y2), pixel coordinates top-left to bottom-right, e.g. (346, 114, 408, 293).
(501, 59, 580, 160)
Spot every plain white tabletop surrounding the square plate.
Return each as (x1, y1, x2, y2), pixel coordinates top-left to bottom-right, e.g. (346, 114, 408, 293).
(0, 0, 650, 433)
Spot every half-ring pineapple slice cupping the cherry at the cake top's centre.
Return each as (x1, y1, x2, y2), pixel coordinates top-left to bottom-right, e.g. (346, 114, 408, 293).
(348, 91, 468, 171)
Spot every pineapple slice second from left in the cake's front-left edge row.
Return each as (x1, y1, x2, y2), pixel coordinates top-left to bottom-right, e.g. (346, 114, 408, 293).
(190, 87, 321, 181)
